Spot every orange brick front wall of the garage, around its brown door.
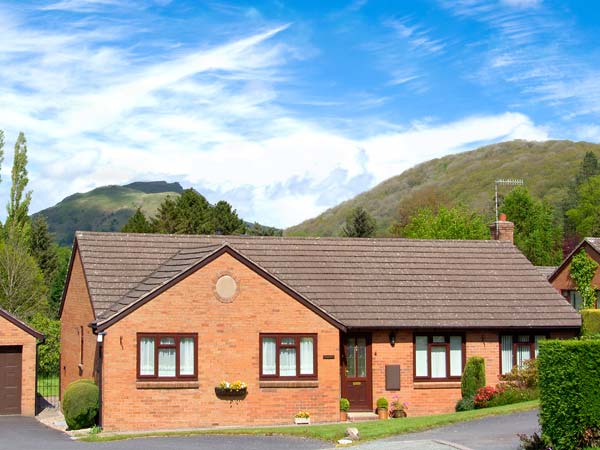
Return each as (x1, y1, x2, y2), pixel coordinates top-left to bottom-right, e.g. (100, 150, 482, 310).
(0, 317, 37, 416)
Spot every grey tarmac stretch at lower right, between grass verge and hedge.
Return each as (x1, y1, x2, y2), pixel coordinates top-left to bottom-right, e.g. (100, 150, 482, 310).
(354, 411, 539, 450)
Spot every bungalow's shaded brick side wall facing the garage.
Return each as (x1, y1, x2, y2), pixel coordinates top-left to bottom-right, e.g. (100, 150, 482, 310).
(60, 248, 96, 399)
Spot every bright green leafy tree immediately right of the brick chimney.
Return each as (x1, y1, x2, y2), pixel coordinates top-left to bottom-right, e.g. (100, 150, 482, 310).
(502, 187, 562, 266)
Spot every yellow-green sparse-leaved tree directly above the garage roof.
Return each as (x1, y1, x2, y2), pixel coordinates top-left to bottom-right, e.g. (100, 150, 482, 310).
(0, 241, 48, 320)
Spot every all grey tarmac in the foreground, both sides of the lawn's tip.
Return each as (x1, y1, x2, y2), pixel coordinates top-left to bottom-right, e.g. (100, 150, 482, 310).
(0, 411, 538, 450)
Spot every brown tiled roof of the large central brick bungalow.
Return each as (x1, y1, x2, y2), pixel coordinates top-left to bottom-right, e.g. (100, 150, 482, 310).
(76, 232, 581, 328)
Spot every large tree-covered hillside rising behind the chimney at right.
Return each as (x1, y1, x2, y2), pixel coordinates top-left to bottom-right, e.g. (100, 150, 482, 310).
(285, 140, 600, 236)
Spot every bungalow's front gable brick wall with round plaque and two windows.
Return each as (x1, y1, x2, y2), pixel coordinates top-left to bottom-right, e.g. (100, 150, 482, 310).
(103, 254, 340, 430)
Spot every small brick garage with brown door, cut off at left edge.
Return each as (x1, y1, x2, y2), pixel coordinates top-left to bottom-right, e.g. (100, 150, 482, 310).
(0, 309, 44, 416)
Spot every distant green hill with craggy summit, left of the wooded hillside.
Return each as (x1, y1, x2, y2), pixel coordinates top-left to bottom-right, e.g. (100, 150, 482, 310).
(34, 181, 183, 245)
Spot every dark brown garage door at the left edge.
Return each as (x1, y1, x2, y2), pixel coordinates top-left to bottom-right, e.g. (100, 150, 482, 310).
(0, 347, 22, 415)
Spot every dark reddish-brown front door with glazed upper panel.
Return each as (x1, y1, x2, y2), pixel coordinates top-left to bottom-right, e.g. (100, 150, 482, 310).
(341, 334, 373, 411)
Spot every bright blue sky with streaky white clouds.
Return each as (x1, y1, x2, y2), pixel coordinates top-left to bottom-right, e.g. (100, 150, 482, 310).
(0, 0, 600, 227)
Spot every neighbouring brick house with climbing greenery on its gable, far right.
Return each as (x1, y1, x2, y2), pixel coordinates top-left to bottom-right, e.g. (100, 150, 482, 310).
(548, 237, 600, 310)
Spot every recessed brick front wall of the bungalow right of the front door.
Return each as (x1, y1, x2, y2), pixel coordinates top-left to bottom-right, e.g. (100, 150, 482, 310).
(372, 330, 576, 416)
